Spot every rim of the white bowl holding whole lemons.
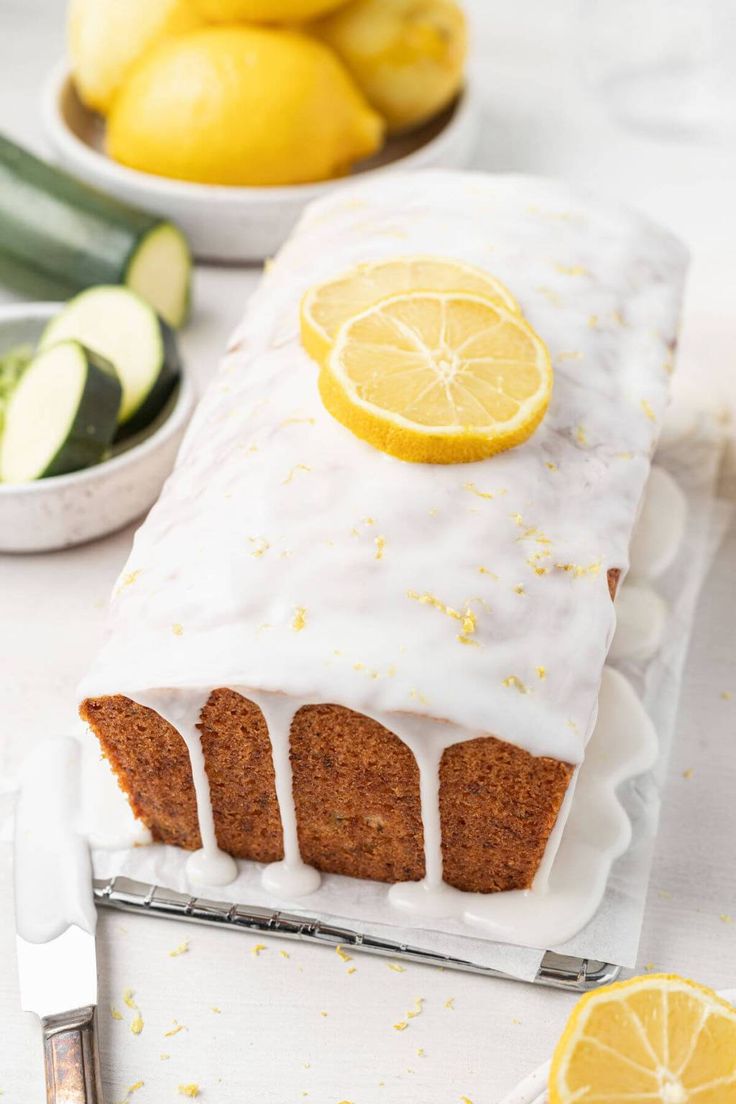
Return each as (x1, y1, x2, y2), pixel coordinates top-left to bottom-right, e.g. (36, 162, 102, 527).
(41, 60, 476, 210)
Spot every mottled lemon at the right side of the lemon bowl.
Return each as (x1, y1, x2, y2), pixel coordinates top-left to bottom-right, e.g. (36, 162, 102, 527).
(311, 0, 467, 134)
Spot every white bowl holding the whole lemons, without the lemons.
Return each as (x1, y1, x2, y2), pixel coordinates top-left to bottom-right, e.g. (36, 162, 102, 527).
(43, 64, 479, 262)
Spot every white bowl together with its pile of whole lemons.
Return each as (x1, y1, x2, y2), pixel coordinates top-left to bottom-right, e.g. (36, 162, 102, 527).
(43, 0, 478, 262)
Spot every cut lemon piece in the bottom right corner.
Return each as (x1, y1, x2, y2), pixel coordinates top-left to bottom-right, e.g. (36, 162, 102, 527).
(550, 974, 736, 1104)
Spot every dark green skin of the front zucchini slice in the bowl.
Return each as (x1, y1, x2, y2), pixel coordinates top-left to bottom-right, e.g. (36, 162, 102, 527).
(39, 342, 122, 479)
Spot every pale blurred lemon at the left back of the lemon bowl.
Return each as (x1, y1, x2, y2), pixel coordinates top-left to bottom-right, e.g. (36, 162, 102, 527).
(66, 0, 204, 115)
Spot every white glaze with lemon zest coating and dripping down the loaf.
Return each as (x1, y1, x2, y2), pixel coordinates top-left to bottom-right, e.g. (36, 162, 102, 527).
(77, 172, 684, 896)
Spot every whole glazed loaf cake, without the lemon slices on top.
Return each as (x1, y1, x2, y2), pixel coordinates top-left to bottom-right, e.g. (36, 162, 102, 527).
(82, 172, 685, 900)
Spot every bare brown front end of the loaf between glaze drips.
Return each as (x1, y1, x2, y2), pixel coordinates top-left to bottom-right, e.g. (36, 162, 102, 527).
(81, 689, 574, 893)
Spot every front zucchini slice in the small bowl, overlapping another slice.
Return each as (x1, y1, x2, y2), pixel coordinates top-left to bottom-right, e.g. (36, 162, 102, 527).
(0, 341, 121, 484)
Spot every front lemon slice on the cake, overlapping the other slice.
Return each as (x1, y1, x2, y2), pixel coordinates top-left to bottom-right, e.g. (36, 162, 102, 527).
(319, 291, 552, 464)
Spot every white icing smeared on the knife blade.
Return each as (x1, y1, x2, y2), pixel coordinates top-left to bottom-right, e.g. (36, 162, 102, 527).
(14, 737, 97, 943)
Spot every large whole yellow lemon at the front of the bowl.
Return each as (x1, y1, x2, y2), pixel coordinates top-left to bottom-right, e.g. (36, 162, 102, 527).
(107, 26, 383, 184)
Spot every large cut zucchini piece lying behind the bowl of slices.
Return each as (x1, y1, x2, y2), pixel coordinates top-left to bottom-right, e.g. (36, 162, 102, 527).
(0, 135, 192, 327)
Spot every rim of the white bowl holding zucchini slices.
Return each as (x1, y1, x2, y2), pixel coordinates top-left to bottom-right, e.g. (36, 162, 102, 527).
(0, 302, 194, 498)
